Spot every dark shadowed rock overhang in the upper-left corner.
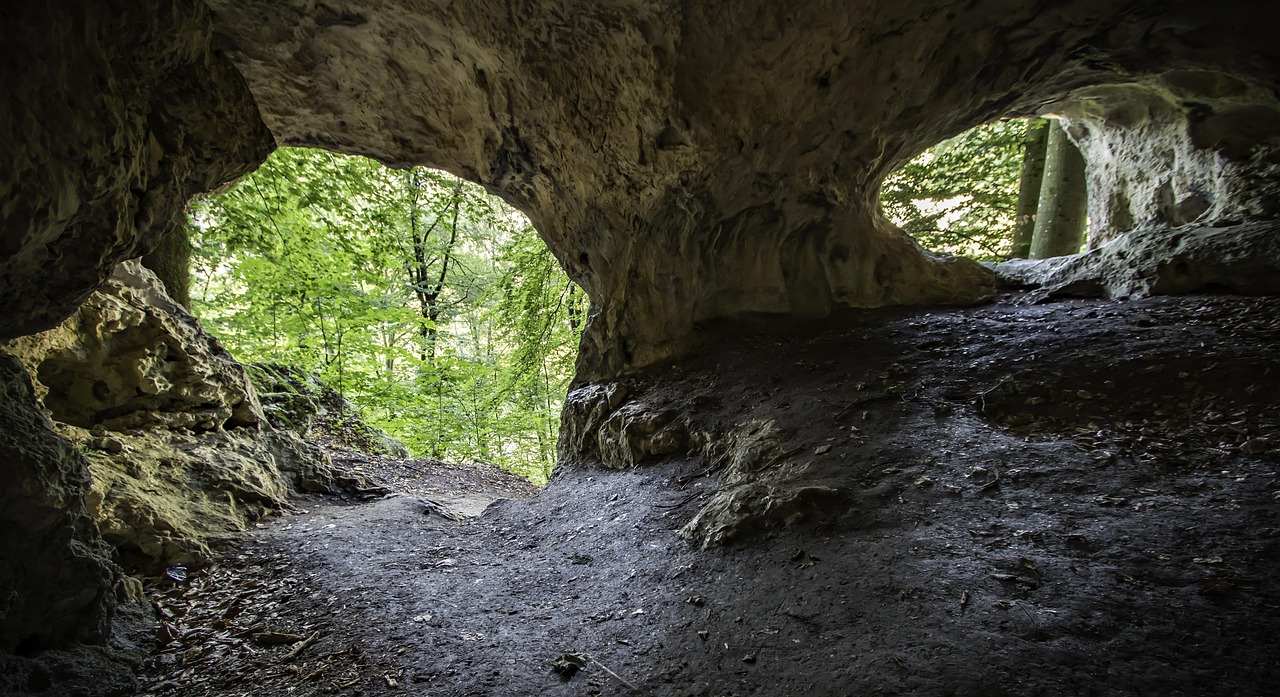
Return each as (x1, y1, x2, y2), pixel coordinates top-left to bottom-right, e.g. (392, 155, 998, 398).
(0, 0, 274, 339)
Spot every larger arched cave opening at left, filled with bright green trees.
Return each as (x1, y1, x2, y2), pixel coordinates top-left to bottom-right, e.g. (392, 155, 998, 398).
(181, 148, 586, 485)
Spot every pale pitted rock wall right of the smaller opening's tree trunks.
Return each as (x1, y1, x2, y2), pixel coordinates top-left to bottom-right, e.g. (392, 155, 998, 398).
(1047, 70, 1280, 247)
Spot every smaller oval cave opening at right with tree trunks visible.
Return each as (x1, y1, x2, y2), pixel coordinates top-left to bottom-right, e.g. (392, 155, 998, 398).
(881, 119, 1088, 262)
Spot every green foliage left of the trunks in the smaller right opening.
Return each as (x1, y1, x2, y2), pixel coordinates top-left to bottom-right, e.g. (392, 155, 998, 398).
(881, 119, 1027, 261)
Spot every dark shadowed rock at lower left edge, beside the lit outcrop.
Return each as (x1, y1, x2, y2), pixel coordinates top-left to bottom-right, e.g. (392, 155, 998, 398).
(0, 353, 120, 652)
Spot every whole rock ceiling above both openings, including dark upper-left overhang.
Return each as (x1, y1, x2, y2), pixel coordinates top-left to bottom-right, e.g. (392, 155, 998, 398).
(5, 0, 1280, 379)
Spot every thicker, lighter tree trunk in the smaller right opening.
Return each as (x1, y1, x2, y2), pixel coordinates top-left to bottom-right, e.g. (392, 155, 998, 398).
(1032, 120, 1089, 258)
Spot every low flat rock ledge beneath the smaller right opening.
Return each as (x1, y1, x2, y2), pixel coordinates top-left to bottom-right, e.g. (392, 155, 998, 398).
(995, 223, 1280, 301)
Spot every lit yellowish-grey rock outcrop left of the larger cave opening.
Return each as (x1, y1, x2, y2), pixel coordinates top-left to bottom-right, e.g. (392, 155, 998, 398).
(3, 261, 337, 570)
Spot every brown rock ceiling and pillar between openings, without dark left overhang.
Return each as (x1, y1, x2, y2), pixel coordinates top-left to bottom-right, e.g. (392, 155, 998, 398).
(197, 0, 1280, 380)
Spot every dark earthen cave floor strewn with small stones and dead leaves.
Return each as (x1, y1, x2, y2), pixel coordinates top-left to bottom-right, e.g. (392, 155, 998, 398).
(135, 295, 1280, 697)
